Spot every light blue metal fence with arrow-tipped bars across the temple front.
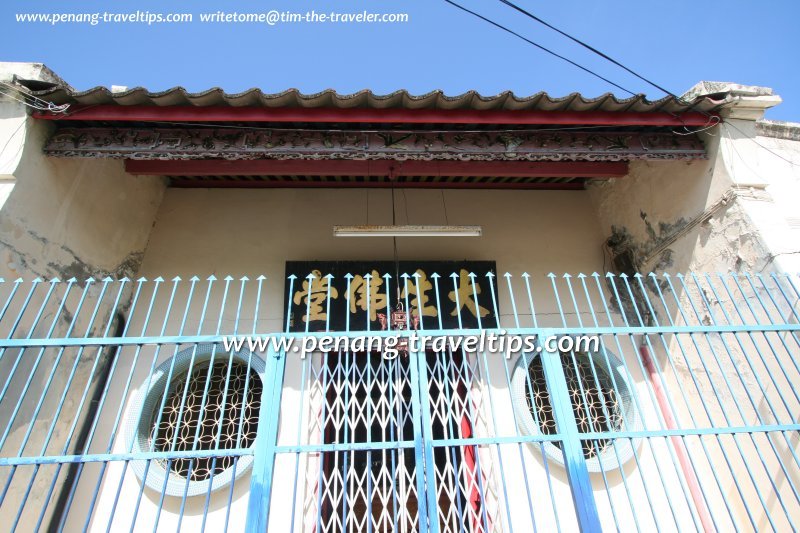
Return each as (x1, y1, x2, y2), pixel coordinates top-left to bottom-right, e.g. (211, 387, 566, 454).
(0, 270, 800, 533)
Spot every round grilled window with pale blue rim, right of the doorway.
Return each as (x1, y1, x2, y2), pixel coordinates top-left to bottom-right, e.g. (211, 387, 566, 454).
(513, 352, 639, 472)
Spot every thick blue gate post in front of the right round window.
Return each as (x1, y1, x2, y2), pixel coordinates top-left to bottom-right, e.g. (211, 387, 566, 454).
(538, 331, 602, 532)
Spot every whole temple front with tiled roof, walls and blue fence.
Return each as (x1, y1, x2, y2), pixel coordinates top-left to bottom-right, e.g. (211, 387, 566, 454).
(0, 63, 800, 532)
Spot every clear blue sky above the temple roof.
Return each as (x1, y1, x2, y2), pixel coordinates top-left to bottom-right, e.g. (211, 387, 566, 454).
(0, 0, 800, 121)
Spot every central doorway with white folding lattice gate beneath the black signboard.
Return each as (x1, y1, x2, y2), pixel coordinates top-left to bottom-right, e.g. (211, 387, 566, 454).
(317, 352, 481, 533)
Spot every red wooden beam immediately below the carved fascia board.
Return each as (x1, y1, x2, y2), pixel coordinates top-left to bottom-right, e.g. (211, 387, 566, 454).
(125, 159, 628, 178)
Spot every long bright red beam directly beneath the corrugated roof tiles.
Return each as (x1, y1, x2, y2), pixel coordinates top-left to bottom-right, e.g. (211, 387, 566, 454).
(33, 105, 709, 126)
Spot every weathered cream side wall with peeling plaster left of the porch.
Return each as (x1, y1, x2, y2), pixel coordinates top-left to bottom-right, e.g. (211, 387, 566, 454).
(0, 82, 165, 528)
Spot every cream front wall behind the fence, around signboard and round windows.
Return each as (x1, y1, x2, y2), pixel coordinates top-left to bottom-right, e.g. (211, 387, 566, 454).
(75, 185, 720, 530)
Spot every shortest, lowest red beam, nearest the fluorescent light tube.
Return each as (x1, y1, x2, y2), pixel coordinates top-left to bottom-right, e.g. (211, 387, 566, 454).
(170, 178, 585, 191)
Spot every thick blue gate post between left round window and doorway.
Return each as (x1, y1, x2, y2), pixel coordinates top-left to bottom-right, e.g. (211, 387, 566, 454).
(245, 343, 286, 533)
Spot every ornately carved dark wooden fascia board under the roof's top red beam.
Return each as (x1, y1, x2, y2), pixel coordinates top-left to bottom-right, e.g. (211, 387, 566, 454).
(45, 128, 706, 161)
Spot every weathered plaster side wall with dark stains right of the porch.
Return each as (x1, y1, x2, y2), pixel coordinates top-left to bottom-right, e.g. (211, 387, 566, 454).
(590, 110, 800, 526)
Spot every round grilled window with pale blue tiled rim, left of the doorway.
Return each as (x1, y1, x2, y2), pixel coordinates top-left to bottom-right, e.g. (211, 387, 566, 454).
(129, 344, 264, 496)
